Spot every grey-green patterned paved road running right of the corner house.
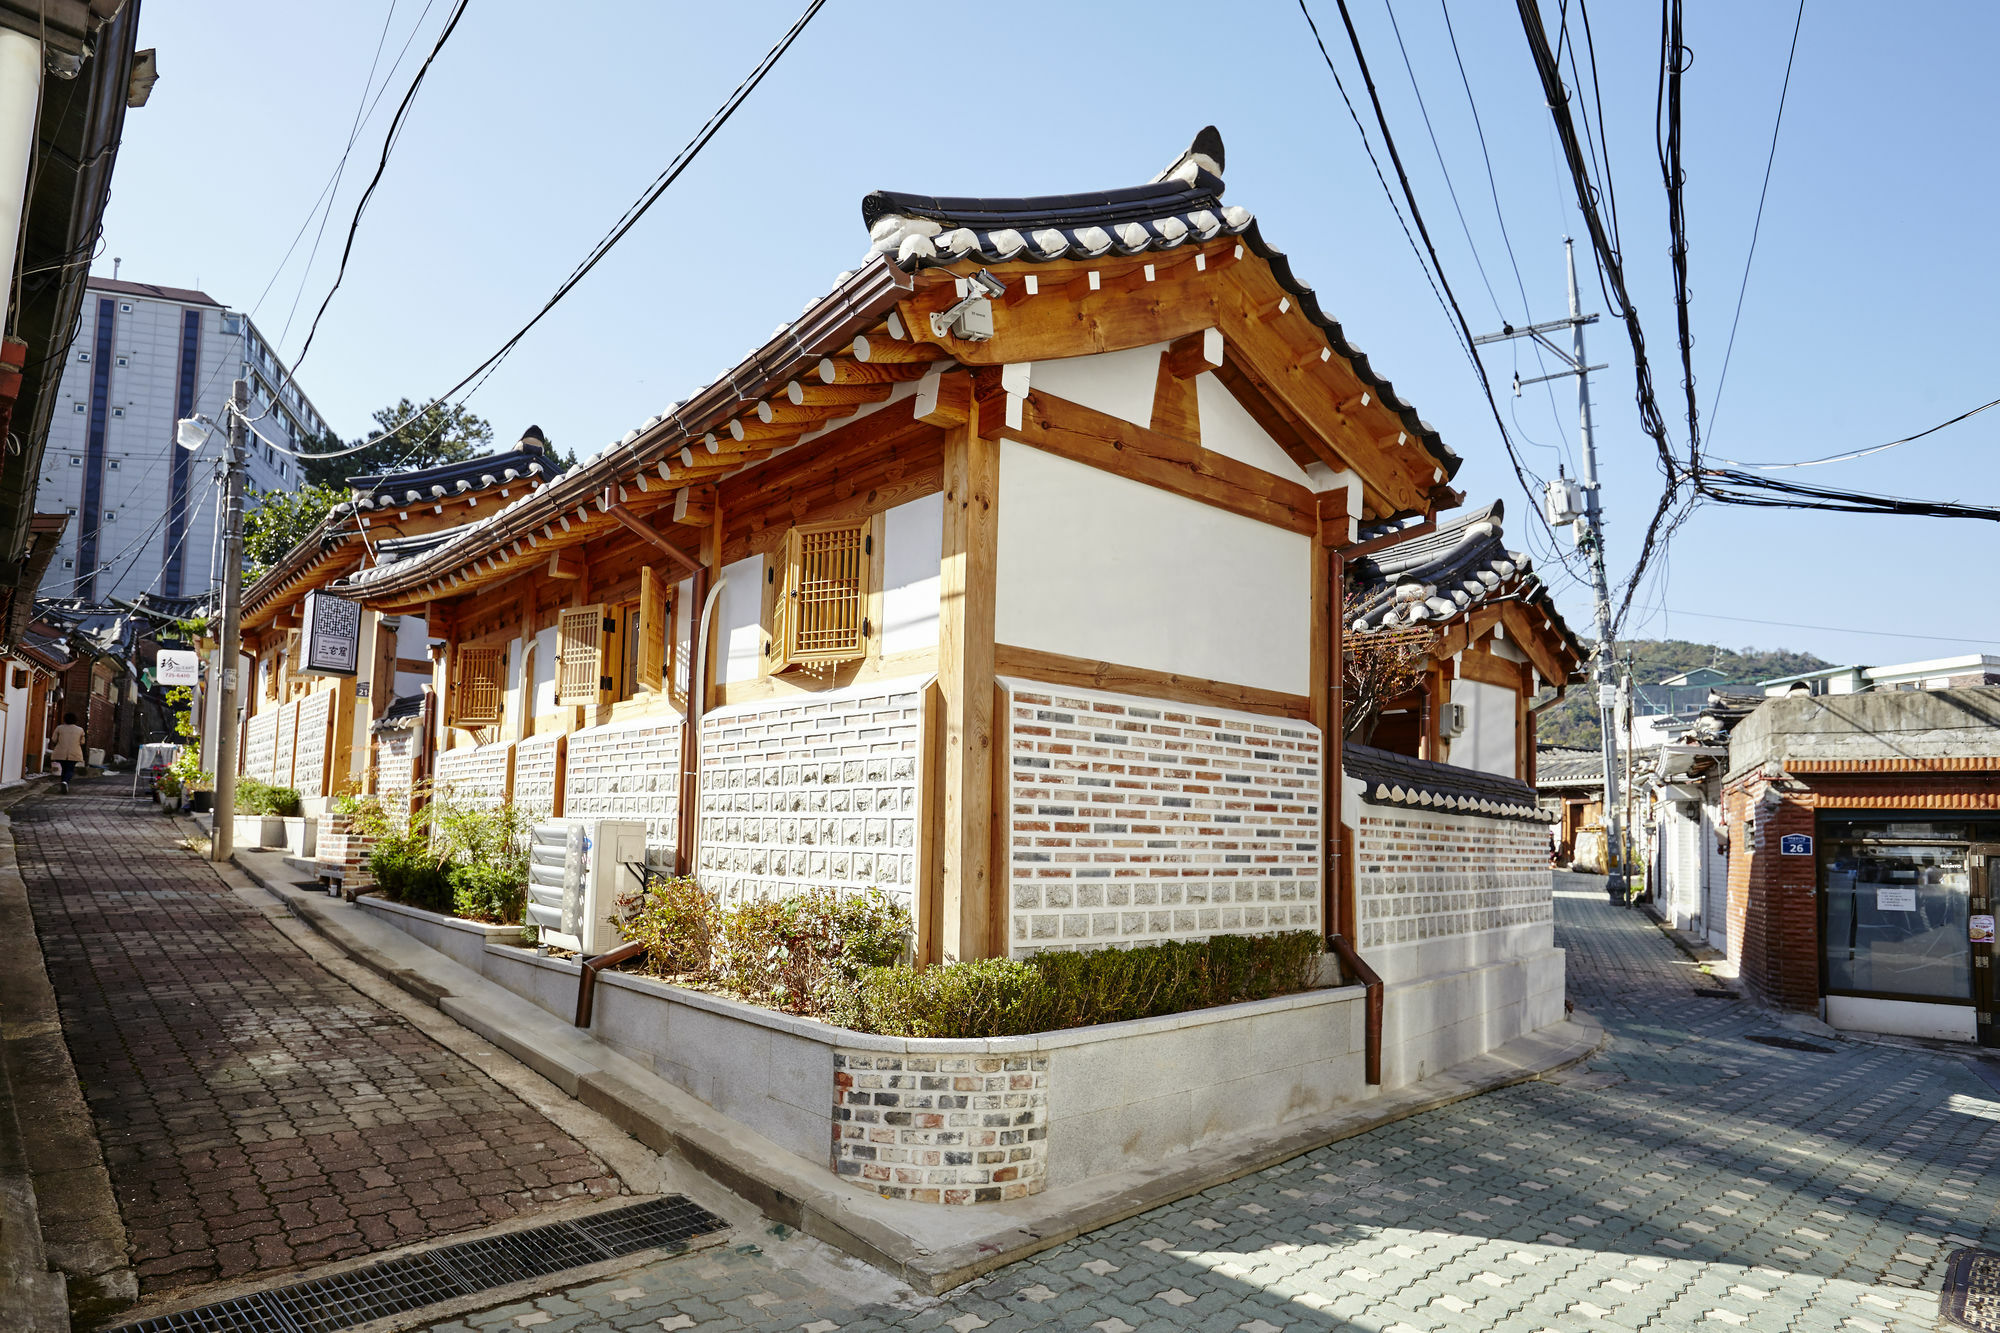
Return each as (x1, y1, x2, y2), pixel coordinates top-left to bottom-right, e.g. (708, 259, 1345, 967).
(426, 875, 2000, 1333)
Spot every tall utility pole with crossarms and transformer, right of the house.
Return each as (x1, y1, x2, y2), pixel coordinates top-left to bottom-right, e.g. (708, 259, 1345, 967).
(1472, 236, 1626, 897)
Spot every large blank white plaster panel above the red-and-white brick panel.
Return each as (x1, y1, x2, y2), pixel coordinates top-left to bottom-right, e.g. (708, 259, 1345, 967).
(996, 440, 1312, 695)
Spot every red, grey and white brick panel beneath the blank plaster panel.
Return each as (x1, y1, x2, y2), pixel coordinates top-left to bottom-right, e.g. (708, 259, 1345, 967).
(996, 681, 1320, 957)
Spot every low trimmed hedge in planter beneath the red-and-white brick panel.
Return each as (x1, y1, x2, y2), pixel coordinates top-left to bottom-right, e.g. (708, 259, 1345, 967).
(826, 931, 1320, 1037)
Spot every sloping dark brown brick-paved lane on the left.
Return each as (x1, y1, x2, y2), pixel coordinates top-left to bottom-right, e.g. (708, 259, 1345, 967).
(14, 777, 618, 1295)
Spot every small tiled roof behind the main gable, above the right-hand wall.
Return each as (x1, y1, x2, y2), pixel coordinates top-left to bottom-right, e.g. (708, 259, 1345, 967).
(1348, 500, 1590, 685)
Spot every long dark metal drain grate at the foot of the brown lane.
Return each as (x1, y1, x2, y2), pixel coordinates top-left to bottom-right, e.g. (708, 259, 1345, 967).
(110, 1195, 724, 1333)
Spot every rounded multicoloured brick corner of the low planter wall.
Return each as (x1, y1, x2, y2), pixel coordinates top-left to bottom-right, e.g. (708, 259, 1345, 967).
(834, 1051, 1048, 1203)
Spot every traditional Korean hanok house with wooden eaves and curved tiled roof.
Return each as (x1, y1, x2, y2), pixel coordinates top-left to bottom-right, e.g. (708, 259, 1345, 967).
(246, 130, 1574, 1083)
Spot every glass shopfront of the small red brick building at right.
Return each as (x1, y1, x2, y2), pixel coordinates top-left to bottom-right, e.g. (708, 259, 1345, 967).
(1818, 817, 1976, 1001)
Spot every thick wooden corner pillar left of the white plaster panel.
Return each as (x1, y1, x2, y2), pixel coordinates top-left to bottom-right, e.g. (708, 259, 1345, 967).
(938, 402, 1006, 959)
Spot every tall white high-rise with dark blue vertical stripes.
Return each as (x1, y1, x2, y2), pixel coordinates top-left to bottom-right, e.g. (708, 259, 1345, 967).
(36, 278, 326, 602)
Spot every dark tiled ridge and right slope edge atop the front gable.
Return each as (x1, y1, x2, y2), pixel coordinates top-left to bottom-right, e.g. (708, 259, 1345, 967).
(862, 126, 1462, 480)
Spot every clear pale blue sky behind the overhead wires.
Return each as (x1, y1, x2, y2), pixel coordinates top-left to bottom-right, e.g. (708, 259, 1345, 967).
(94, 0, 2000, 662)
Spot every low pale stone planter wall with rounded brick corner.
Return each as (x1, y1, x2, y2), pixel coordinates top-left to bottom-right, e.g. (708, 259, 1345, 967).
(362, 899, 1378, 1203)
